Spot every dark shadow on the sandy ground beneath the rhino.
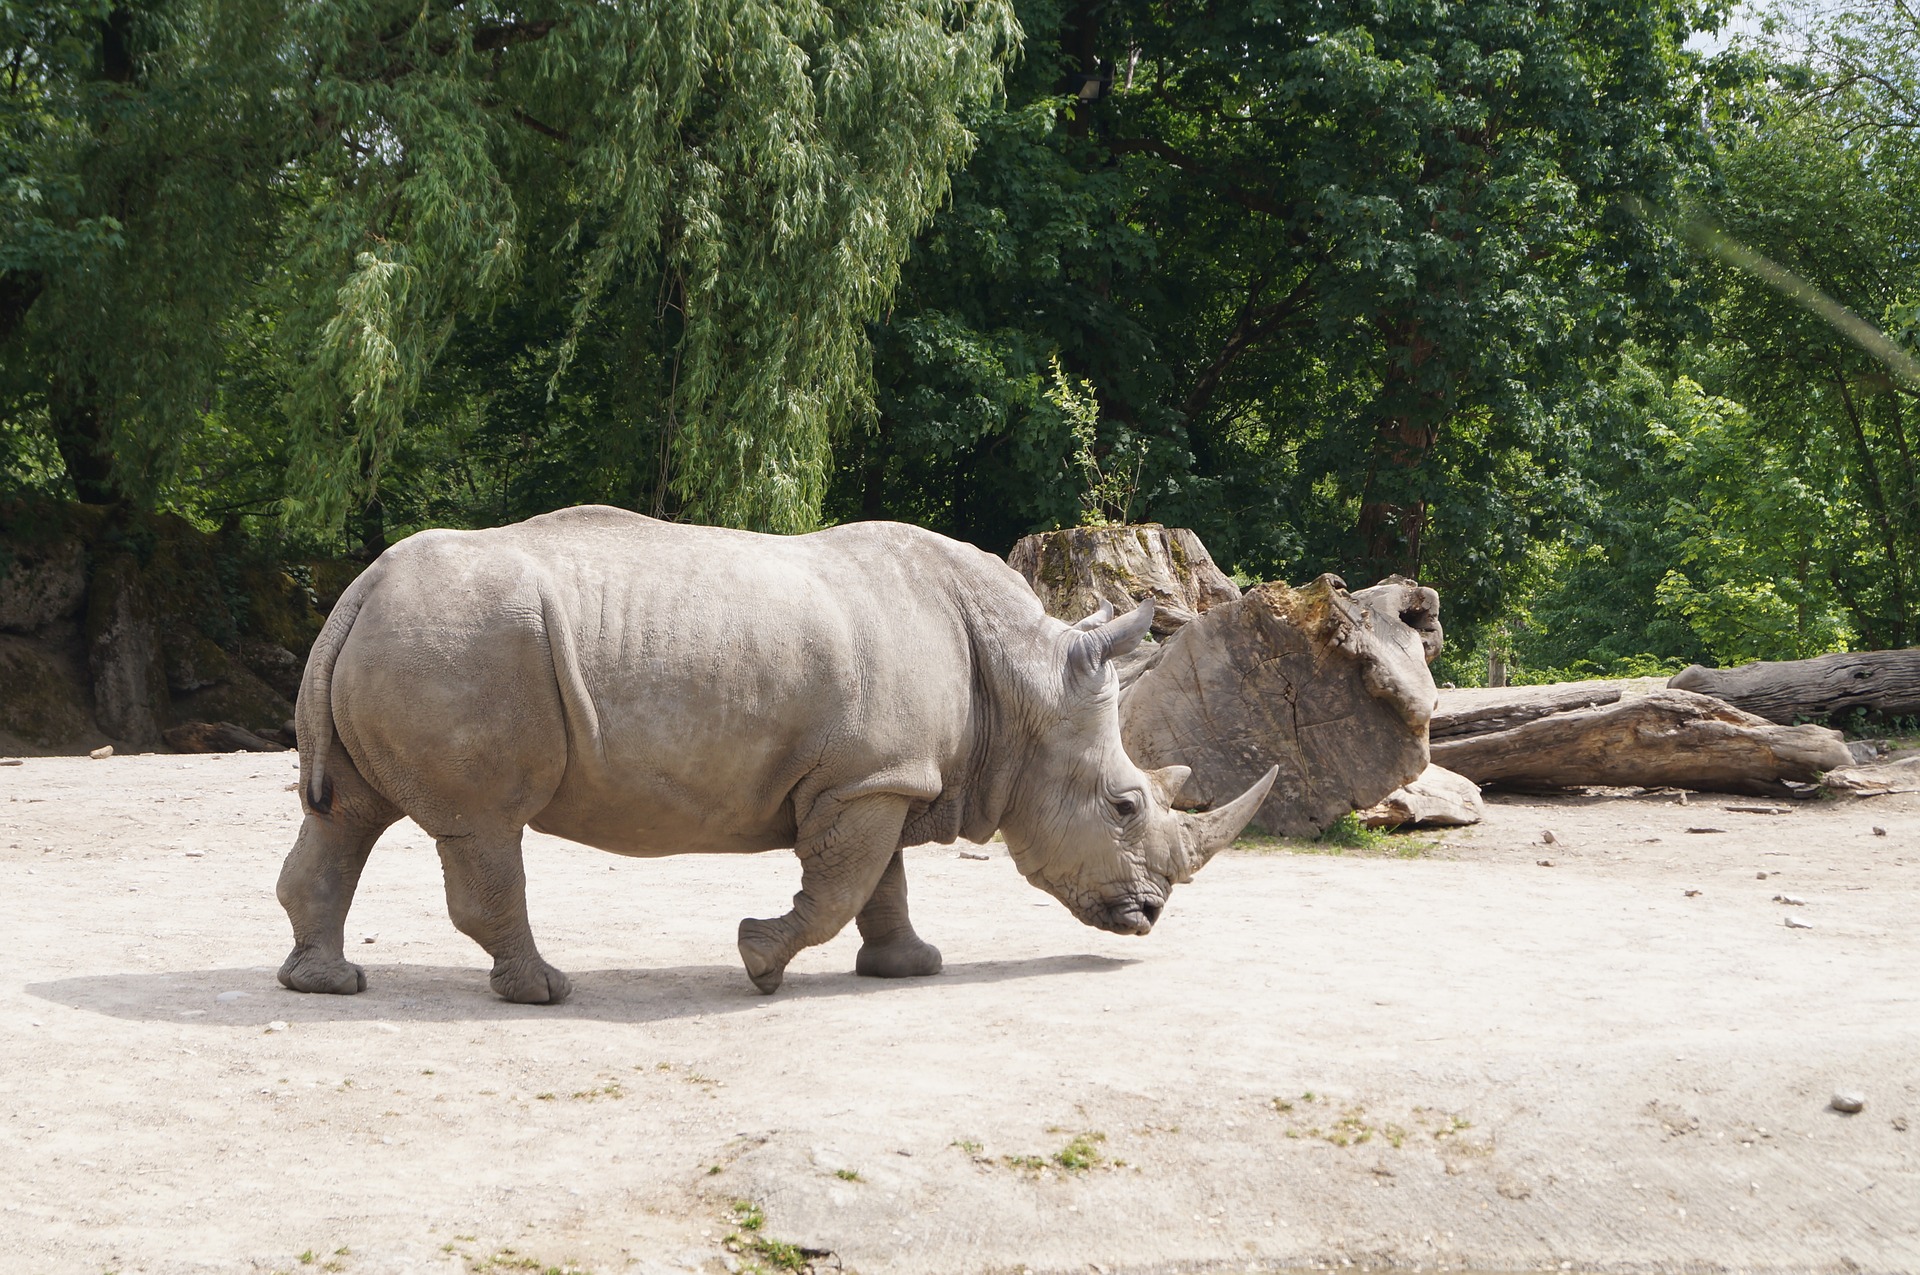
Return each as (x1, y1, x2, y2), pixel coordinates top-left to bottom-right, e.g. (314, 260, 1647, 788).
(25, 954, 1137, 1027)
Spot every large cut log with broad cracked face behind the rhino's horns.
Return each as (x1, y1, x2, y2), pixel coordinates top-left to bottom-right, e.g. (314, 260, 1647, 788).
(1119, 576, 1438, 837)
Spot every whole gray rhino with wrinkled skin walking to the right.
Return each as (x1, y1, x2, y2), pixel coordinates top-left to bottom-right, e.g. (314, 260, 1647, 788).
(280, 507, 1273, 1002)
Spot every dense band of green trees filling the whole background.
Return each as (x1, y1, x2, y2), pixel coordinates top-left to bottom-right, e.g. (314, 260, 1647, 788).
(0, 0, 1920, 678)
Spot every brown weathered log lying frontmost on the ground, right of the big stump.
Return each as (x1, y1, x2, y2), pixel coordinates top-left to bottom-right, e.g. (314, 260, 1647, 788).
(1432, 689, 1853, 797)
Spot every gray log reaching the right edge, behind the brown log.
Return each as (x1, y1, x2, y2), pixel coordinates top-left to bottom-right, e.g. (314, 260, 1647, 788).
(1667, 647, 1920, 724)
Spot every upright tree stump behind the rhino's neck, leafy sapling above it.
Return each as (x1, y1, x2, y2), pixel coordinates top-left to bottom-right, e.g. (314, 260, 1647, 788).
(1006, 522, 1240, 638)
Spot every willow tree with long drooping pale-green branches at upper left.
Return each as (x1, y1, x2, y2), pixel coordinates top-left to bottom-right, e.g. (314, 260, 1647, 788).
(0, 0, 1018, 530)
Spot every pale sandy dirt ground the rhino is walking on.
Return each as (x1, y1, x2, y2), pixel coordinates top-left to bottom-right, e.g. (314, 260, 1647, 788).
(0, 755, 1920, 1275)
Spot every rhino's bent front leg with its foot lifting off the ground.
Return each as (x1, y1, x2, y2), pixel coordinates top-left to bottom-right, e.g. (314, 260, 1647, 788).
(739, 793, 906, 993)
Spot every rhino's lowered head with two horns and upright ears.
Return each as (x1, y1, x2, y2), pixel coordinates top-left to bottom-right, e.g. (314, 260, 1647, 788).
(1002, 599, 1279, 935)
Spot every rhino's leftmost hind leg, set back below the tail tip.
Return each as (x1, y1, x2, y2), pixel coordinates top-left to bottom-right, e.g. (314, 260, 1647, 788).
(276, 814, 388, 997)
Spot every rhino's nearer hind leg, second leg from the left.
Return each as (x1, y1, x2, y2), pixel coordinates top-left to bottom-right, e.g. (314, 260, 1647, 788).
(434, 828, 572, 1004)
